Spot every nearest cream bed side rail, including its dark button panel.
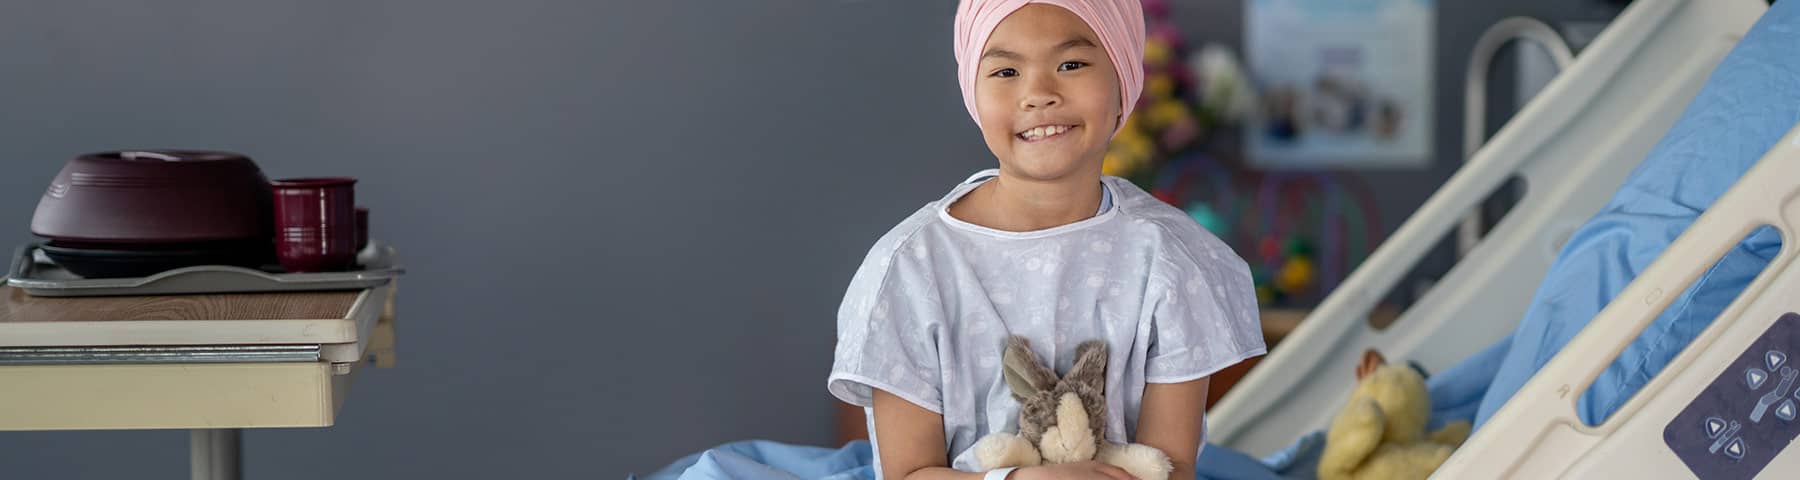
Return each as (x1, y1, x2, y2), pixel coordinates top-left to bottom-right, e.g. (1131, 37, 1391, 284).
(1435, 126, 1800, 478)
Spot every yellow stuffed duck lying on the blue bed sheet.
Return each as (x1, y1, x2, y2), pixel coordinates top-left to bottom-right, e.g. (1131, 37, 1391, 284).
(1319, 351, 1469, 480)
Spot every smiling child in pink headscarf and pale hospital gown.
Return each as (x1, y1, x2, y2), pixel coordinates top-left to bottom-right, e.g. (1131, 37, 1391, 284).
(828, 0, 1264, 480)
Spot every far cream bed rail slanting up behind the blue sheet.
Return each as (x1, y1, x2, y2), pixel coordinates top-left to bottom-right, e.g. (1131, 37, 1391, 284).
(1208, 0, 1768, 458)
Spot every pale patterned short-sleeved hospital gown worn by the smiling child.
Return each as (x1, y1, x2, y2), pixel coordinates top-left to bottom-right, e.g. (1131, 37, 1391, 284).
(826, 171, 1265, 471)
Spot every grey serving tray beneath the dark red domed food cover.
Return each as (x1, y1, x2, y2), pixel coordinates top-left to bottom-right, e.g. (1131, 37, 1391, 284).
(5, 239, 405, 297)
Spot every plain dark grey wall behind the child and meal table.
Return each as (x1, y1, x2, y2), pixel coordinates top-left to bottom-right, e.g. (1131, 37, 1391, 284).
(0, 0, 1604, 478)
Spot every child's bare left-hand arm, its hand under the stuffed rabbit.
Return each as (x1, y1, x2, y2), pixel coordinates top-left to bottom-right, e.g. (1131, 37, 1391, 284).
(875, 388, 1123, 480)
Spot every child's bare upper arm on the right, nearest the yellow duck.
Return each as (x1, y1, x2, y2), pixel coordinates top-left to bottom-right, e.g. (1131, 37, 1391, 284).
(1138, 378, 1211, 478)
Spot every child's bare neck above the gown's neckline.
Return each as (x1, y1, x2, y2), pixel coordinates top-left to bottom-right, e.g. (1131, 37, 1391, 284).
(950, 169, 1103, 232)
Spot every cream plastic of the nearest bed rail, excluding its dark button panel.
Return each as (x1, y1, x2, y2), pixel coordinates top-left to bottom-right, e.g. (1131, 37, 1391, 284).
(1433, 126, 1800, 478)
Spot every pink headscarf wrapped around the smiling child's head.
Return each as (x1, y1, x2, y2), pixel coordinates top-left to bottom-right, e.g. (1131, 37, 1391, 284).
(952, 0, 1143, 135)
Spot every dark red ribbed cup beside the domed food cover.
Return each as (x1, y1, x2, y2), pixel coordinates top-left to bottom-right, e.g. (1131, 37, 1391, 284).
(270, 178, 356, 271)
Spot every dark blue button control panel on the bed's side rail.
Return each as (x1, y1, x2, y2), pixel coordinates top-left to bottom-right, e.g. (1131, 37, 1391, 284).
(1663, 313, 1800, 480)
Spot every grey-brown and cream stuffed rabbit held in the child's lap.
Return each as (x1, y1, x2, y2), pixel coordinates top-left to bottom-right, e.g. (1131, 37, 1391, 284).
(976, 336, 1170, 480)
